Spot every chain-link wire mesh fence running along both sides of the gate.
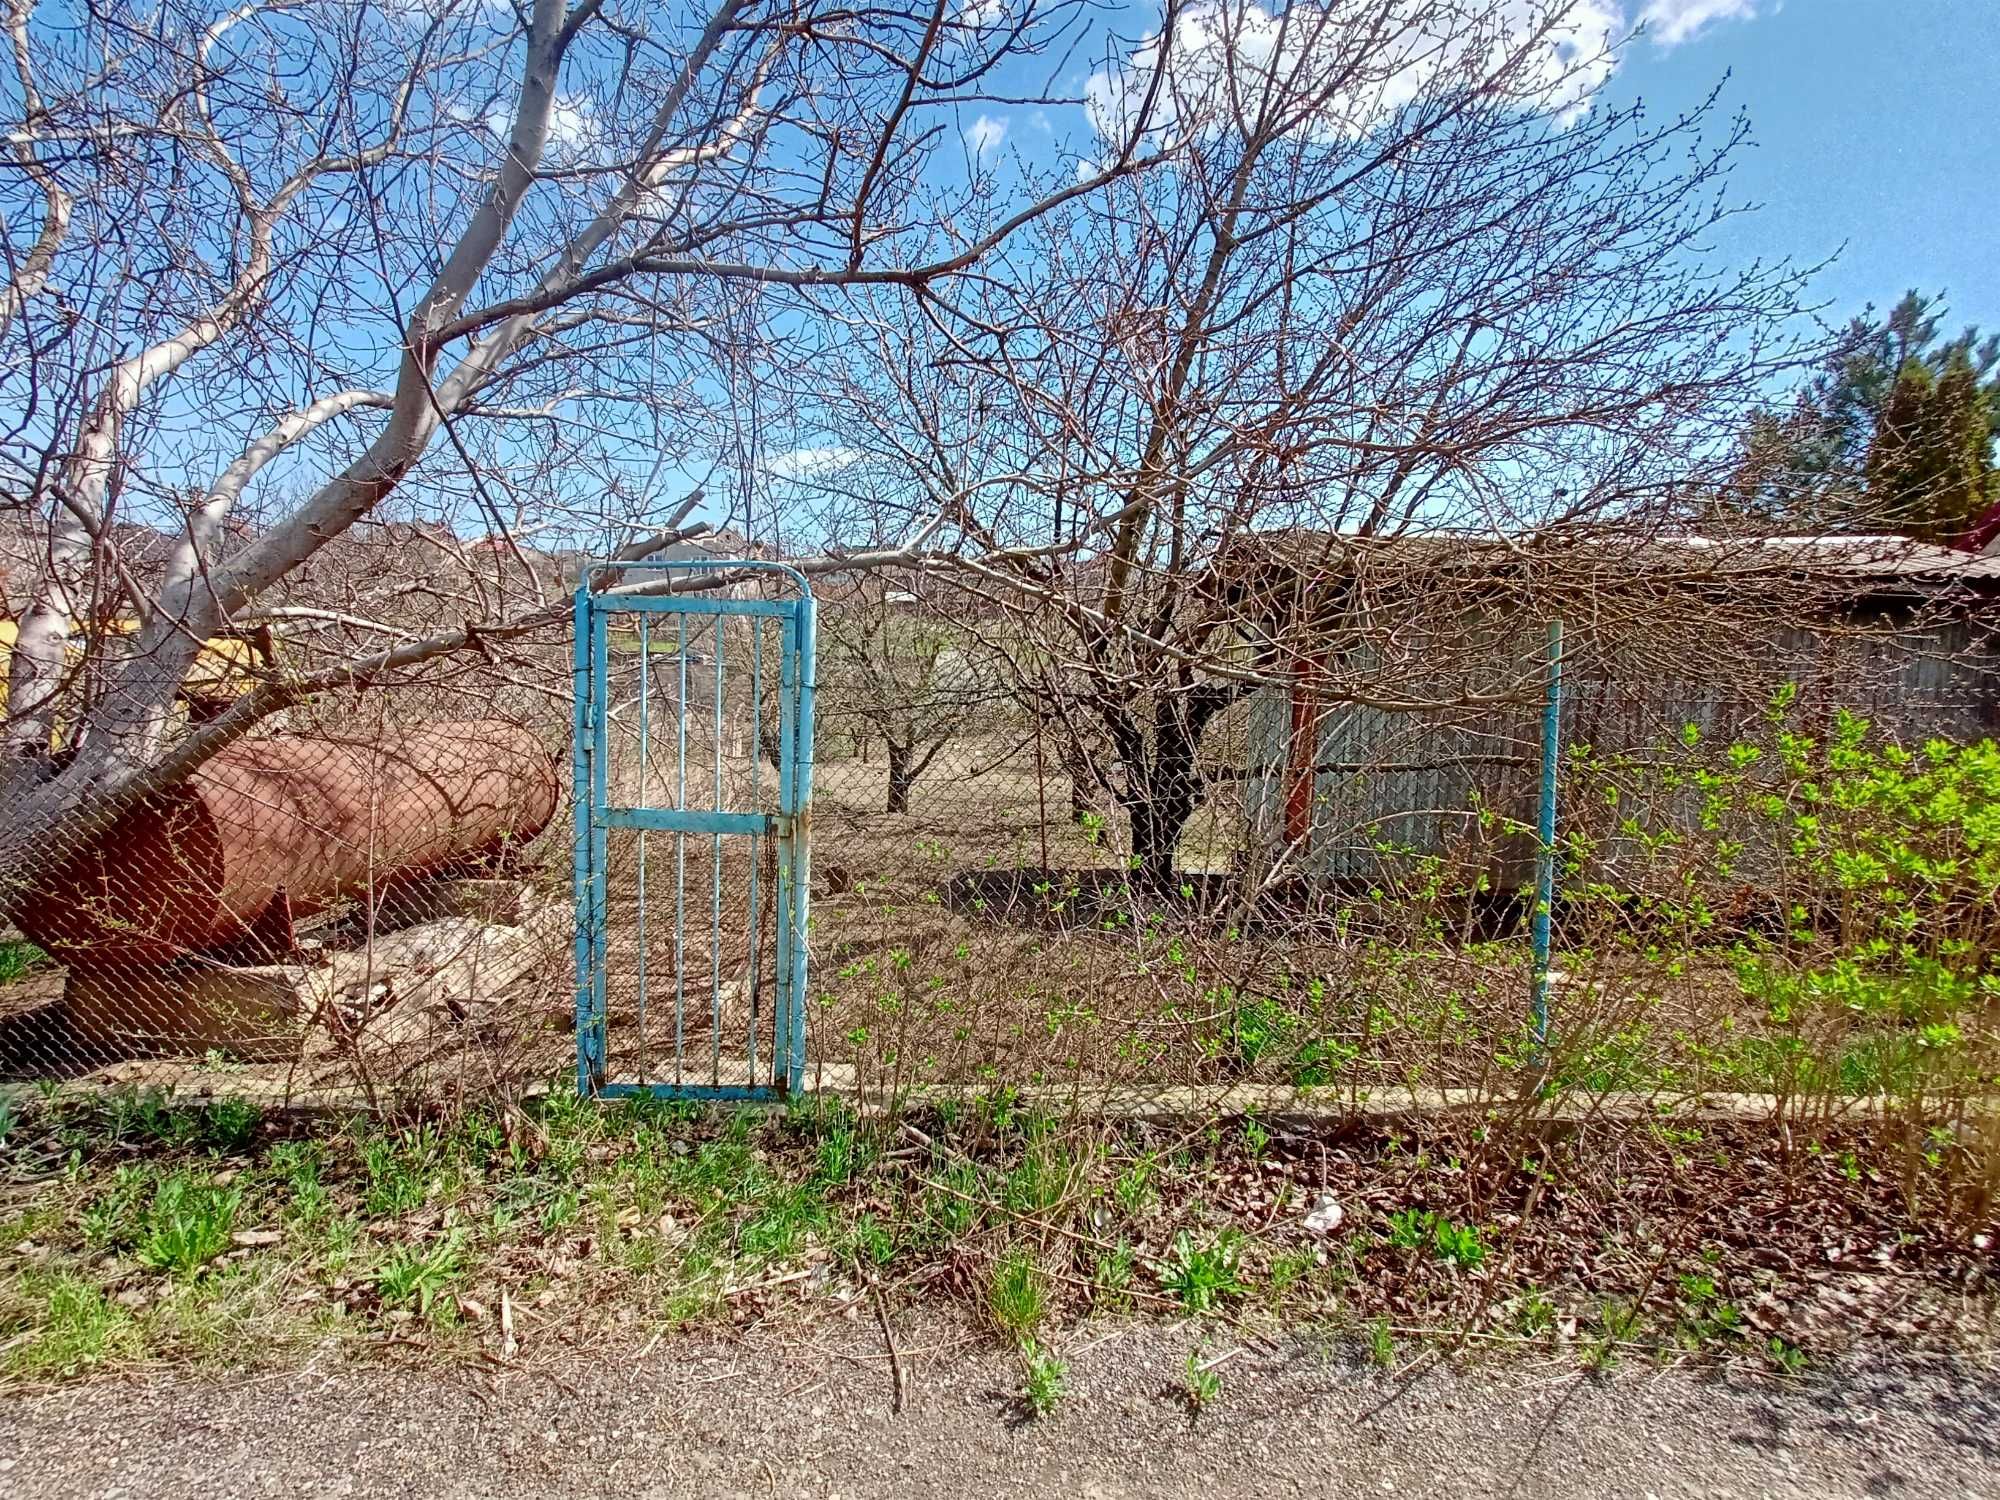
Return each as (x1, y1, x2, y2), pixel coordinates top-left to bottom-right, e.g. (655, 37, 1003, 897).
(0, 540, 2000, 1136)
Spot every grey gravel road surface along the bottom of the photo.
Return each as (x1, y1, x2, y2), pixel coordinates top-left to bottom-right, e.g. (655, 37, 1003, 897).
(0, 1320, 2000, 1500)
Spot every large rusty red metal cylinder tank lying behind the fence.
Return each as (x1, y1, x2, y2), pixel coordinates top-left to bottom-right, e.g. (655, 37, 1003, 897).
(14, 720, 560, 964)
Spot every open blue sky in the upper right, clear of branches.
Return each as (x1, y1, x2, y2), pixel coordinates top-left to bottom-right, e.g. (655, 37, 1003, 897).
(1606, 0, 2000, 340)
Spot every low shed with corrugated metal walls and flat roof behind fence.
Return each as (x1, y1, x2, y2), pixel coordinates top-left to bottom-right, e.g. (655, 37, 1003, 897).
(1220, 532, 2000, 884)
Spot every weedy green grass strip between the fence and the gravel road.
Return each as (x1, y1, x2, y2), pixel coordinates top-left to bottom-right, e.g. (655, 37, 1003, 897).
(0, 1072, 1984, 1410)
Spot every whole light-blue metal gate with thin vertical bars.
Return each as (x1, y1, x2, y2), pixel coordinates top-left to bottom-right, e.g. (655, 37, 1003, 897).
(574, 558, 814, 1100)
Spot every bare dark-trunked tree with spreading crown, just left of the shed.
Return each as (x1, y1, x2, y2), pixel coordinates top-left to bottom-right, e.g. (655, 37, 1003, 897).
(788, 0, 1824, 890)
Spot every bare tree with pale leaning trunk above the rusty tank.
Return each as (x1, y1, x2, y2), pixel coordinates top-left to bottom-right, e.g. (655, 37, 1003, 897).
(0, 0, 1158, 900)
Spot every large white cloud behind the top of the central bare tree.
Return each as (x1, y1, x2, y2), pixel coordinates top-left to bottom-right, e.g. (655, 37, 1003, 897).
(1084, 0, 1624, 138)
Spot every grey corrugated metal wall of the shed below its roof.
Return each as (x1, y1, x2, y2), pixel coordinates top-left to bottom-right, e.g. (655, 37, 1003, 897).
(1246, 620, 2000, 890)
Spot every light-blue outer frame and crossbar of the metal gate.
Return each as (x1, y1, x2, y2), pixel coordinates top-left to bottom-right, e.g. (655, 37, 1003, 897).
(570, 558, 818, 1102)
